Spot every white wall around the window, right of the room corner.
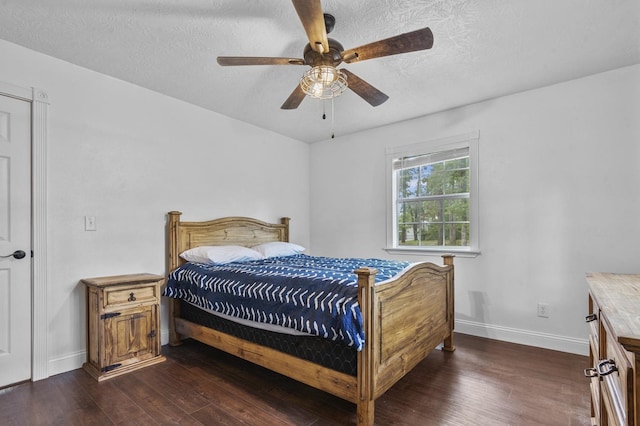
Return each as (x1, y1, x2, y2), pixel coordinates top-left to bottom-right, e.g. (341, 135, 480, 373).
(311, 65, 640, 354)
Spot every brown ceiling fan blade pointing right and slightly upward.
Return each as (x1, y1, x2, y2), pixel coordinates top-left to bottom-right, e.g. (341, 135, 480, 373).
(342, 27, 433, 63)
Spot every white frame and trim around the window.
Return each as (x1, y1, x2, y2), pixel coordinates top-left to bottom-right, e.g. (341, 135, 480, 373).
(385, 131, 480, 256)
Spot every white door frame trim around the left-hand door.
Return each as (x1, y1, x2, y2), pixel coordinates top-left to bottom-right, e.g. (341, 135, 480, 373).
(0, 81, 49, 381)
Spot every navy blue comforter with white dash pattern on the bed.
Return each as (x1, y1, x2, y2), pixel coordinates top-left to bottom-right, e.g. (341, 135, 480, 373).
(163, 254, 409, 351)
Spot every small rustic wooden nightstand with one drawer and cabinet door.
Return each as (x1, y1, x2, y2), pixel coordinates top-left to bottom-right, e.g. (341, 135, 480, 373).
(82, 274, 165, 381)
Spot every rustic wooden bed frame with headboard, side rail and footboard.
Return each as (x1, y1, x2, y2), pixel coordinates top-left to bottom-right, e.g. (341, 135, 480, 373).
(168, 211, 455, 425)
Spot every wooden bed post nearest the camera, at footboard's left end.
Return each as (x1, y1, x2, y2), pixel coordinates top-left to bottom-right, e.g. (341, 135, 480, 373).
(355, 268, 378, 425)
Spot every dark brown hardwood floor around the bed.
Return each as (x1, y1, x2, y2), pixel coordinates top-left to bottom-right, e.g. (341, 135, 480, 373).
(0, 334, 590, 426)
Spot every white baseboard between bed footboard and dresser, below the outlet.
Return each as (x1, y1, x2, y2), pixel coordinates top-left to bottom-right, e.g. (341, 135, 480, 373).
(455, 320, 589, 356)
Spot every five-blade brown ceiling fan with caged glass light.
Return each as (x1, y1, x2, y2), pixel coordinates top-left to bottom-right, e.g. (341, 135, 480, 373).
(218, 0, 433, 109)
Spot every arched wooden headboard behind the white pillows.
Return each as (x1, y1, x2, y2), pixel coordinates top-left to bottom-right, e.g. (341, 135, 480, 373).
(169, 211, 289, 271)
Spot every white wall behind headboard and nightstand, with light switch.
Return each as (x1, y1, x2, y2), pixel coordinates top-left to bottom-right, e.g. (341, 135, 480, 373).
(0, 40, 310, 374)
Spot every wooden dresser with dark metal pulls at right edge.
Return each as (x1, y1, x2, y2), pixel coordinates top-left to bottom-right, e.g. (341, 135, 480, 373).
(585, 273, 640, 426)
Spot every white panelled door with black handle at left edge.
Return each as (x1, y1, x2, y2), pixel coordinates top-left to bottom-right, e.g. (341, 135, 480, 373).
(0, 96, 31, 387)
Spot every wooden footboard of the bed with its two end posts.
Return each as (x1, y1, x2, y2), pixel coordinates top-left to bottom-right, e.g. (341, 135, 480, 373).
(355, 255, 455, 425)
